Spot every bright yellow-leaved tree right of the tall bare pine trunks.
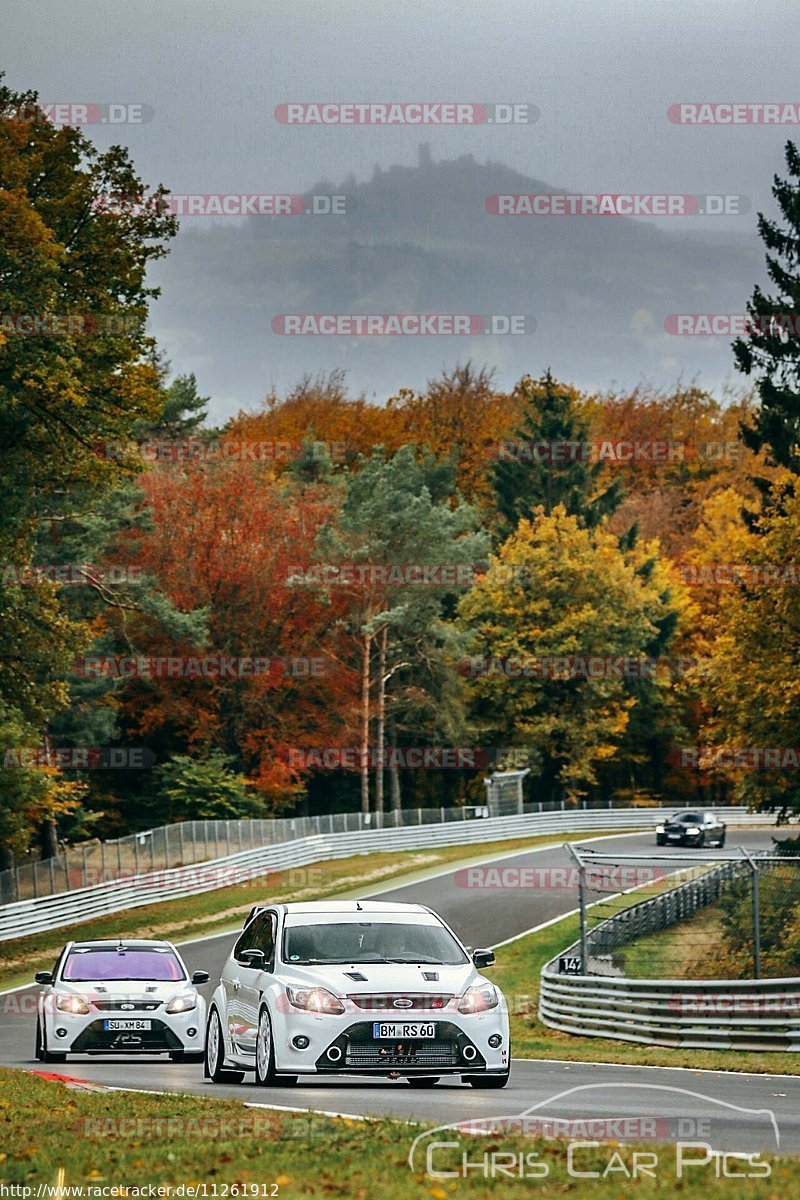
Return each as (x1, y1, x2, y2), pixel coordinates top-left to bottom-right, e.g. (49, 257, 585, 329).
(459, 505, 675, 799)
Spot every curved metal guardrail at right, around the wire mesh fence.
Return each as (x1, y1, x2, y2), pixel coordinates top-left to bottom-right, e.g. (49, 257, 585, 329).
(539, 859, 800, 1051)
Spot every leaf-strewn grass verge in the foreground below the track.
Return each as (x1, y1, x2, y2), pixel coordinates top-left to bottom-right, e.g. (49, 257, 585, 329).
(0, 1069, 800, 1200)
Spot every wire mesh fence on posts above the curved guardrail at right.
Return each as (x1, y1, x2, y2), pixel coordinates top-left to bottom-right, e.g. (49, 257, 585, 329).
(572, 851, 800, 979)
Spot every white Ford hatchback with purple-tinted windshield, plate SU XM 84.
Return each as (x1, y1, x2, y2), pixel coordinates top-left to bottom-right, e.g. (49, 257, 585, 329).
(36, 940, 209, 1062)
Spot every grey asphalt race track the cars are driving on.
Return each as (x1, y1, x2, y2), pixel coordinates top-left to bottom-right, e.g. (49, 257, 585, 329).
(0, 828, 800, 1152)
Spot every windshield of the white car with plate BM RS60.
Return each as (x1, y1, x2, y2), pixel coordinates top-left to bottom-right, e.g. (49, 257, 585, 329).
(283, 920, 468, 966)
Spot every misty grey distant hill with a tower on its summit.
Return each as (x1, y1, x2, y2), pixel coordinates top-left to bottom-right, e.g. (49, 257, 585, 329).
(146, 148, 764, 416)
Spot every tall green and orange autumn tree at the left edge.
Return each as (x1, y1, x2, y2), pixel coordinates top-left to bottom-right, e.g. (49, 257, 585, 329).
(0, 83, 176, 848)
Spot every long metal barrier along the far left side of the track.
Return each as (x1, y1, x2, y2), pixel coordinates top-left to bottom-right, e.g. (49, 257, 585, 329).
(0, 808, 775, 941)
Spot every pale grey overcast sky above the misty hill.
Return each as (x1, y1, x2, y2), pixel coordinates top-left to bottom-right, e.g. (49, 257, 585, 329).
(2, 0, 800, 229)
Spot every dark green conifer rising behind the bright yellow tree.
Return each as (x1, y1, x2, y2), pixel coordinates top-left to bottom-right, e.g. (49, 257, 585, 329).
(491, 371, 622, 538)
